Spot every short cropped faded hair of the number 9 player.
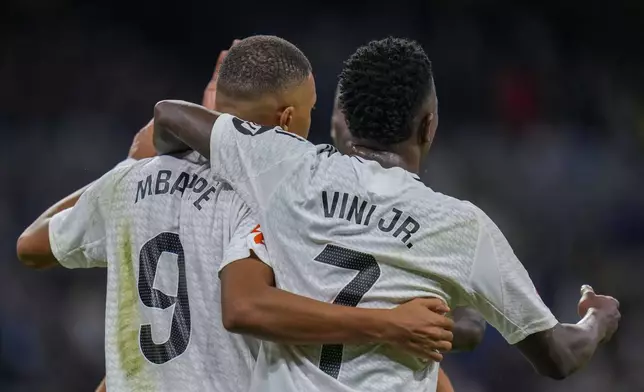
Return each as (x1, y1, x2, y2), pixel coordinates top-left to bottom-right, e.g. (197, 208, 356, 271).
(217, 35, 311, 99)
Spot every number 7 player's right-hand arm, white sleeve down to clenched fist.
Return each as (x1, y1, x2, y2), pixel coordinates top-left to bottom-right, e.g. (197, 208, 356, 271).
(465, 210, 620, 379)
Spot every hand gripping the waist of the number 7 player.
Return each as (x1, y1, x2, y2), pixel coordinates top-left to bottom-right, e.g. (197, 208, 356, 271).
(390, 298, 454, 362)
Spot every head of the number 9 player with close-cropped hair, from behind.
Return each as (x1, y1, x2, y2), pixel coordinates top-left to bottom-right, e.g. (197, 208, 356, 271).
(215, 35, 317, 138)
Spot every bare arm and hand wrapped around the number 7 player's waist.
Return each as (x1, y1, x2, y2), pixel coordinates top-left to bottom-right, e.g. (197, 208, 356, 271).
(220, 258, 453, 361)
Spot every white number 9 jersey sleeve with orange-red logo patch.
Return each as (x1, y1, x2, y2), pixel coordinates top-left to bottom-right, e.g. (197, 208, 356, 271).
(219, 196, 271, 271)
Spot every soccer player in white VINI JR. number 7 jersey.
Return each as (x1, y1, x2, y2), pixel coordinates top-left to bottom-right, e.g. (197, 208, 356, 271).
(155, 38, 620, 392)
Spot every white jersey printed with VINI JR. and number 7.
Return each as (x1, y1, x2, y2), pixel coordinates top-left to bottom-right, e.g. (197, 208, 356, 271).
(210, 115, 557, 392)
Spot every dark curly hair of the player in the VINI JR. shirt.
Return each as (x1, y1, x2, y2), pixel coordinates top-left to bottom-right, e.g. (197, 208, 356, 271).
(339, 37, 433, 145)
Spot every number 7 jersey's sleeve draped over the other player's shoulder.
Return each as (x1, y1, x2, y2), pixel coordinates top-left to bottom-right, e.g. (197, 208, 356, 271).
(210, 114, 315, 211)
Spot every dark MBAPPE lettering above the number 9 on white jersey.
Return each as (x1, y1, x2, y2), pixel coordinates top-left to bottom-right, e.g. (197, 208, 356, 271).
(134, 170, 217, 210)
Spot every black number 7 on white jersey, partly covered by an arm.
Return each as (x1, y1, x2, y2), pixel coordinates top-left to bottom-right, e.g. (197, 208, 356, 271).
(314, 245, 380, 378)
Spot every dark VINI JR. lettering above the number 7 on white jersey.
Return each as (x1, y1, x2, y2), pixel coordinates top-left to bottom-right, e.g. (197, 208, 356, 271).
(322, 191, 420, 249)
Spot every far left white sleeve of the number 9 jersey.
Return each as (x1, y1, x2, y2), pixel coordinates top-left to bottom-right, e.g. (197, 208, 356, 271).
(49, 173, 109, 268)
